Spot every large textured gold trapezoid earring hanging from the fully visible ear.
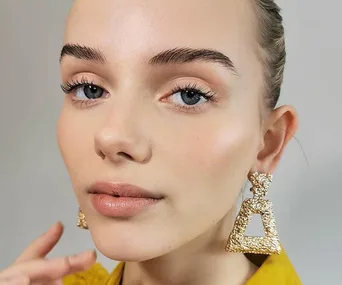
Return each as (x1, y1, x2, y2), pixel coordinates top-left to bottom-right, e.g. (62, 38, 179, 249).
(226, 172, 281, 255)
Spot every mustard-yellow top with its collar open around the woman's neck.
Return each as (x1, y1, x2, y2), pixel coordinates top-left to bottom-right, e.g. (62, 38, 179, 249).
(63, 250, 302, 285)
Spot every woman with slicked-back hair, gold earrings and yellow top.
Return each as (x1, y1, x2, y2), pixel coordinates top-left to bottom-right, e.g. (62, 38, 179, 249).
(0, 0, 301, 285)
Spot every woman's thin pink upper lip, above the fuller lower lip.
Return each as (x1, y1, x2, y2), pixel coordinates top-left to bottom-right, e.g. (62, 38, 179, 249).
(88, 181, 163, 199)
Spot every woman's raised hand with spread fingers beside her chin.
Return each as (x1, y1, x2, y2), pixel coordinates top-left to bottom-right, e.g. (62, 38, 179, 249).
(0, 223, 96, 285)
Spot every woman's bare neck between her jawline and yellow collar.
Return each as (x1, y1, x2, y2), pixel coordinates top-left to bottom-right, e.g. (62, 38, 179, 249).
(123, 213, 257, 285)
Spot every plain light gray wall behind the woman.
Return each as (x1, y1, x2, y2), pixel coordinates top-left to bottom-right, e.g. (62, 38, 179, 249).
(0, 0, 342, 285)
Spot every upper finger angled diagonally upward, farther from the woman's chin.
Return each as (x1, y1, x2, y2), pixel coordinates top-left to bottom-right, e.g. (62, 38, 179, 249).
(14, 222, 64, 264)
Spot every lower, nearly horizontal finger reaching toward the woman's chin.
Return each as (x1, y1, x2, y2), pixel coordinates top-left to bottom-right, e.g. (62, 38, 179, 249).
(0, 251, 96, 283)
